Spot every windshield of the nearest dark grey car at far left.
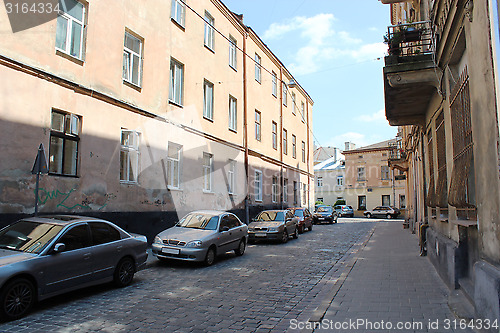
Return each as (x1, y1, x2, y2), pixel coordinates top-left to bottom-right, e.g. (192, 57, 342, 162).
(0, 220, 63, 254)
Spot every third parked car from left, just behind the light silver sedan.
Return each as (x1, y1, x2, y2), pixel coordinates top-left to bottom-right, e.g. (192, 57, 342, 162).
(248, 210, 299, 243)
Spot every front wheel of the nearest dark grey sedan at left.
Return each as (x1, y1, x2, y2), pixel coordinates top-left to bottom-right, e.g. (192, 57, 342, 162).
(0, 279, 35, 320)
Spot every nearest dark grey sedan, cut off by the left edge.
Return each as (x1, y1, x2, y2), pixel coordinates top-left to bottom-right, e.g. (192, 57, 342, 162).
(0, 215, 147, 320)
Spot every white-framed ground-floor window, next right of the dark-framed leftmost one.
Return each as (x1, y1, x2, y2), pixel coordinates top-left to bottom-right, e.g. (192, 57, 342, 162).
(120, 129, 139, 183)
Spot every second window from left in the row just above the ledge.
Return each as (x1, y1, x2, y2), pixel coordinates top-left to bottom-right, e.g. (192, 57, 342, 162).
(123, 32, 142, 87)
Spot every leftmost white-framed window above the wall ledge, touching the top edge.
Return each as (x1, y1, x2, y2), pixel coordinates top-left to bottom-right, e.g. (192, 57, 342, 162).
(56, 0, 85, 59)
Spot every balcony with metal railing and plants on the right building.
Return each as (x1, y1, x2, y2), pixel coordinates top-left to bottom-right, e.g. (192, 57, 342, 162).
(384, 21, 439, 126)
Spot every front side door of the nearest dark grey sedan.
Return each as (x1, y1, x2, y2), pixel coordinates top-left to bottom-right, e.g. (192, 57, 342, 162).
(43, 223, 93, 294)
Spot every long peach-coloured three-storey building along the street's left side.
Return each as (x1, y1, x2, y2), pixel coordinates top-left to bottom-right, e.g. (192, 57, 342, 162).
(0, 0, 314, 237)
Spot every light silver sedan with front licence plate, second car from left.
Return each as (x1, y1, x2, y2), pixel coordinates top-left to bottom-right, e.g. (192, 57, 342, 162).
(152, 210, 248, 266)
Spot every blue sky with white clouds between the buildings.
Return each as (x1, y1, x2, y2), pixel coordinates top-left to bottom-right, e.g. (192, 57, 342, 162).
(222, 0, 397, 149)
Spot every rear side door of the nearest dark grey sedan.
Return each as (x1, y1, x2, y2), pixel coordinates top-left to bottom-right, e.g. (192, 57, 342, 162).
(88, 221, 124, 280)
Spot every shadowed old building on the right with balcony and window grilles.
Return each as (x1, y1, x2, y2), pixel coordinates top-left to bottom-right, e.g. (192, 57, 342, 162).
(381, 0, 500, 324)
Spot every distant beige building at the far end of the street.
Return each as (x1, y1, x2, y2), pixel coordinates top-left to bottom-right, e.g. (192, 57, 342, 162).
(343, 139, 406, 217)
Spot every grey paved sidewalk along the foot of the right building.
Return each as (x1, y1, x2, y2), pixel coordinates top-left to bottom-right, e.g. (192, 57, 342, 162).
(312, 221, 473, 333)
